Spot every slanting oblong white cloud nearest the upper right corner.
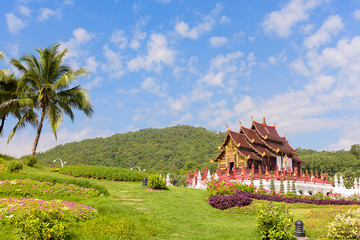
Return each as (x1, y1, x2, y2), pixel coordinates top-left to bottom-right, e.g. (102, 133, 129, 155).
(304, 15, 344, 48)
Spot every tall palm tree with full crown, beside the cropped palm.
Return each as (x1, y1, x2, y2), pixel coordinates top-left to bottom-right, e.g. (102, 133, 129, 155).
(8, 44, 93, 155)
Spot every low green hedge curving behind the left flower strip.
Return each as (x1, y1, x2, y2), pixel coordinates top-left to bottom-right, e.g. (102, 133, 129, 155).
(0, 172, 109, 195)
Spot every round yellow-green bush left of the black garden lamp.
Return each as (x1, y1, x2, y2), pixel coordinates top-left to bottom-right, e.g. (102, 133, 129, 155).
(256, 202, 295, 240)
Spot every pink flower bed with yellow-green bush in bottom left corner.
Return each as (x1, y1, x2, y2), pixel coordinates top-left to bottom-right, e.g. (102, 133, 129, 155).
(0, 197, 98, 239)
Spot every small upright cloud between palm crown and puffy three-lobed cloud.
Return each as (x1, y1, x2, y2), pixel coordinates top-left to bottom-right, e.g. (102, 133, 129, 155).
(101, 45, 125, 78)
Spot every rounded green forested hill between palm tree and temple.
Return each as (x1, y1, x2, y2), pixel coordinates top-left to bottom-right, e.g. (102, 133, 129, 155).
(37, 126, 225, 172)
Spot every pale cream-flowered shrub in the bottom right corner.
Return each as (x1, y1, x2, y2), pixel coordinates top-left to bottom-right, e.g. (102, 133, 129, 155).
(327, 209, 360, 239)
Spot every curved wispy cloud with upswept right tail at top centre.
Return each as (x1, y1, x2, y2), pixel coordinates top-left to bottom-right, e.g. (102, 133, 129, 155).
(175, 3, 223, 39)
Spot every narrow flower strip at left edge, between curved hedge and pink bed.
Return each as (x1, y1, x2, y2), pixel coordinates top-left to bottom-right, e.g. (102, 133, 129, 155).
(0, 179, 100, 197)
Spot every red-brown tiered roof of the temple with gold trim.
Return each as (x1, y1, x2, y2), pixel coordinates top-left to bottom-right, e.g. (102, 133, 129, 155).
(213, 118, 303, 162)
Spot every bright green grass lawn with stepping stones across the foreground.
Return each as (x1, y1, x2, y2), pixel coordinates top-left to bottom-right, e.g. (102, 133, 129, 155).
(0, 167, 358, 240)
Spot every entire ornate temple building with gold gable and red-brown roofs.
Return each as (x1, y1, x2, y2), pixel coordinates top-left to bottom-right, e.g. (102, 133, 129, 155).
(210, 117, 304, 173)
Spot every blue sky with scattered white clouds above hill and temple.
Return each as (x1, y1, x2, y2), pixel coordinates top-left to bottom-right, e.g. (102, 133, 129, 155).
(0, 0, 360, 156)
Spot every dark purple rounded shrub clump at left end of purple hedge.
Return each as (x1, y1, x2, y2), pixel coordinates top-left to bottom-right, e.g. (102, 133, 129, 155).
(209, 191, 252, 210)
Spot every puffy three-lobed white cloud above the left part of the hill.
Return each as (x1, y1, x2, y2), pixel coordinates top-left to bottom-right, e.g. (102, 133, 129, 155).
(127, 33, 176, 71)
